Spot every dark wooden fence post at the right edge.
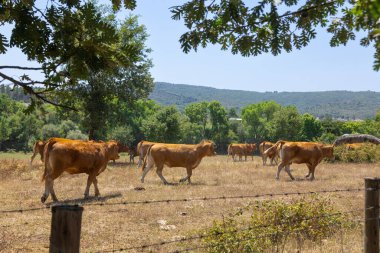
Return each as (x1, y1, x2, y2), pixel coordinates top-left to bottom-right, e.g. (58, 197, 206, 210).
(364, 178, 380, 253)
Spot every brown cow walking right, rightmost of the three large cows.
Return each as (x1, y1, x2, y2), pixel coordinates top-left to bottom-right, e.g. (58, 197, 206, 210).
(265, 141, 334, 180)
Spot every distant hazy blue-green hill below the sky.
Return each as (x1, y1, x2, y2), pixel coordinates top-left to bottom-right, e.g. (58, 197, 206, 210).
(150, 82, 380, 119)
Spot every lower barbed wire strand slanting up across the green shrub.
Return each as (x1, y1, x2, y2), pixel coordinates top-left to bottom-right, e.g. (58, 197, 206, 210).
(98, 206, 374, 252)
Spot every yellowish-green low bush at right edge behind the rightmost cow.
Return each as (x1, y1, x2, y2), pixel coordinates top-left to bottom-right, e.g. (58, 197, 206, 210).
(330, 144, 380, 163)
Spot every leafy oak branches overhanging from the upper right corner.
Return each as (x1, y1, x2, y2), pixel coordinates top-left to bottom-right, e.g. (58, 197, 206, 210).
(171, 0, 380, 71)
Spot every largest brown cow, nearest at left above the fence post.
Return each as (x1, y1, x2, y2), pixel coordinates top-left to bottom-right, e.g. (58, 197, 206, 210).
(41, 138, 119, 203)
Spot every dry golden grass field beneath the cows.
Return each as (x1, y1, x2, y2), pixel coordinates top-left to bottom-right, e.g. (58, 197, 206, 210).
(0, 152, 380, 252)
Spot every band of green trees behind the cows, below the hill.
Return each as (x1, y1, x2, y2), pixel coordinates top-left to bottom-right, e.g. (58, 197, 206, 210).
(0, 89, 380, 153)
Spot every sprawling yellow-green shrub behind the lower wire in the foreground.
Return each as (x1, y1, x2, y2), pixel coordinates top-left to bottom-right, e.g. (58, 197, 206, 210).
(203, 196, 353, 253)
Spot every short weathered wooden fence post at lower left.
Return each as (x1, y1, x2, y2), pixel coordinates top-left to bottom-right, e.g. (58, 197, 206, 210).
(49, 205, 83, 253)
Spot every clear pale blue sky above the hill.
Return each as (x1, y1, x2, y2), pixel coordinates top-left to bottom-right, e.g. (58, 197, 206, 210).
(0, 0, 380, 92)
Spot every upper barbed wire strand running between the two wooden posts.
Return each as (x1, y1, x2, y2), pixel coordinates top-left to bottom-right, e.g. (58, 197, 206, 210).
(0, 188, 364, 213)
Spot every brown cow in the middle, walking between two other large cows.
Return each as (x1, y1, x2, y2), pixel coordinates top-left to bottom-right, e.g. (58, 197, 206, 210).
(141, 140, 215, 185)
